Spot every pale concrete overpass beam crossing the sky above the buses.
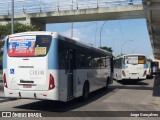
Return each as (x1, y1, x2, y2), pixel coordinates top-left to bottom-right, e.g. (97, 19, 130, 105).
(0, 5, 145, 30)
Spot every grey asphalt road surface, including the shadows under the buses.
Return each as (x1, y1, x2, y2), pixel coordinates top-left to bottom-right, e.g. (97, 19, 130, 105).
(0, 78, 160, 120)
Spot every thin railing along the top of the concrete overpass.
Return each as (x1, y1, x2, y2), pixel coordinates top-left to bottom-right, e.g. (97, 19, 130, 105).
(0, 0, 142, 15)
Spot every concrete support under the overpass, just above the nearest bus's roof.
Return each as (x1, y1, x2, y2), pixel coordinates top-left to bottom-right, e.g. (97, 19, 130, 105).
(26, 18, 46, 31)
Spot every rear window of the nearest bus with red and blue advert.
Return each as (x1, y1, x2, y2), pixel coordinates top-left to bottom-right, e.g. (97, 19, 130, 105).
(7, 35, 52, 57)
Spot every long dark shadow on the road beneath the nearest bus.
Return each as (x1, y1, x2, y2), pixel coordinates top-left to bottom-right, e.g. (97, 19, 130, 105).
(14, 87, 115, 112)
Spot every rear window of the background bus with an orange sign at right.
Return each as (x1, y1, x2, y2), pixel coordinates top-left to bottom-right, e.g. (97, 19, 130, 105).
(124, 56, 145, 64)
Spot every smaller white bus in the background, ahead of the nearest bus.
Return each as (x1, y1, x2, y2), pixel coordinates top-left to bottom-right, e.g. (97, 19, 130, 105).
(114, 54, 146, 80)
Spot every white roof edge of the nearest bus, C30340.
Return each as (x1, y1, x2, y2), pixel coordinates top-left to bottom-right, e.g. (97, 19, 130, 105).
(8, 31, 112, 56)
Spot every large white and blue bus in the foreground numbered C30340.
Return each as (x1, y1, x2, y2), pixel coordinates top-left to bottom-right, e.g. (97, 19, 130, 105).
(3, 32, 113, 102)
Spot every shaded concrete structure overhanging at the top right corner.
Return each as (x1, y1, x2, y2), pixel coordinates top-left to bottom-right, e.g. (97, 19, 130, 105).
(143, 0, 160, 59)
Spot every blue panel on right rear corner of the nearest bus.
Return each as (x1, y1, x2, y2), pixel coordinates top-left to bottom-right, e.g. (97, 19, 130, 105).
(48, 38, 58, 69)
